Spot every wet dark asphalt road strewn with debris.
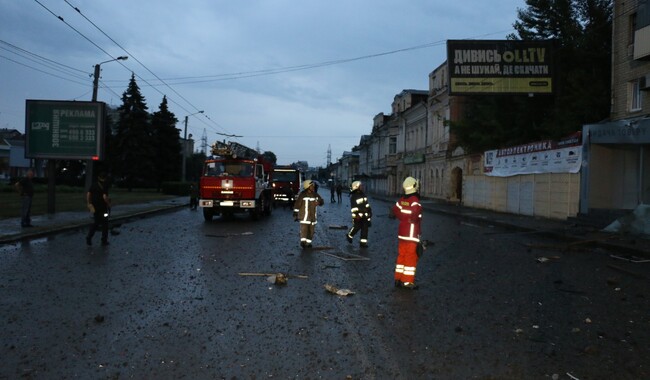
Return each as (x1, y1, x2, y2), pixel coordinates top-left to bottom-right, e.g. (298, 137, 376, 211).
(0, 194, 650, 380)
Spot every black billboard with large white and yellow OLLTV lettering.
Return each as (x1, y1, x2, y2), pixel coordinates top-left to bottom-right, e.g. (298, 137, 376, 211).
(447, 40, 553, 95)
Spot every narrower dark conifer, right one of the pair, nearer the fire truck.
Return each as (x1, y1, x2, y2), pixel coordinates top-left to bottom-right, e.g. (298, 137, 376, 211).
(151, 96, 182, 189)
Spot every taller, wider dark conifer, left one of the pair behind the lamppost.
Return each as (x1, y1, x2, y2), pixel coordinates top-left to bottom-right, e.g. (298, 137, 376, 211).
(111, 74, 157, 191)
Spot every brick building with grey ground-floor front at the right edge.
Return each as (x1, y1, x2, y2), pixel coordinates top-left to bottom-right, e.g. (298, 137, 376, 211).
(580, 0, 650, 215)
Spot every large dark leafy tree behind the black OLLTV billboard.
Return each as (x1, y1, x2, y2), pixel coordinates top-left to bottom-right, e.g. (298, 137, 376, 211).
(450, 0, 612, 153)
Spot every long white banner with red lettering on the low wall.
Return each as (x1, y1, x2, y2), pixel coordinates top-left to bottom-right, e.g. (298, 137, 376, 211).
(483, 133, 582, 177)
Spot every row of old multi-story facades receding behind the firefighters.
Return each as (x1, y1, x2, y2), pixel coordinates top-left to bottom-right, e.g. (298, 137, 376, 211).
(357, 71, 468, 202)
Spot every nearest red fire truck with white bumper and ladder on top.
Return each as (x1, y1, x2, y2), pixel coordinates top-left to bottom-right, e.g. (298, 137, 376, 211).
(199, 141, 273, 222)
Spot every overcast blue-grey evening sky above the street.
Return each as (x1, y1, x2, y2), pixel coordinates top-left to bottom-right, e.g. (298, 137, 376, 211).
(0, 0, 525, 166)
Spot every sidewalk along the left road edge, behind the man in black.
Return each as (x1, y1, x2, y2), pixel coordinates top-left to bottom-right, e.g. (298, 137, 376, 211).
(0, 197, 188, 245)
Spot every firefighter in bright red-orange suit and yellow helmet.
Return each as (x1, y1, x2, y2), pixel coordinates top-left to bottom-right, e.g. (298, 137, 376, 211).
(391, 177, 422, 289)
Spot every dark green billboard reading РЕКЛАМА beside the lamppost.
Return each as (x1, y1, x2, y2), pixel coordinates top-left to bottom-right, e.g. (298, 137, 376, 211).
(25, 99, 106, 160)
